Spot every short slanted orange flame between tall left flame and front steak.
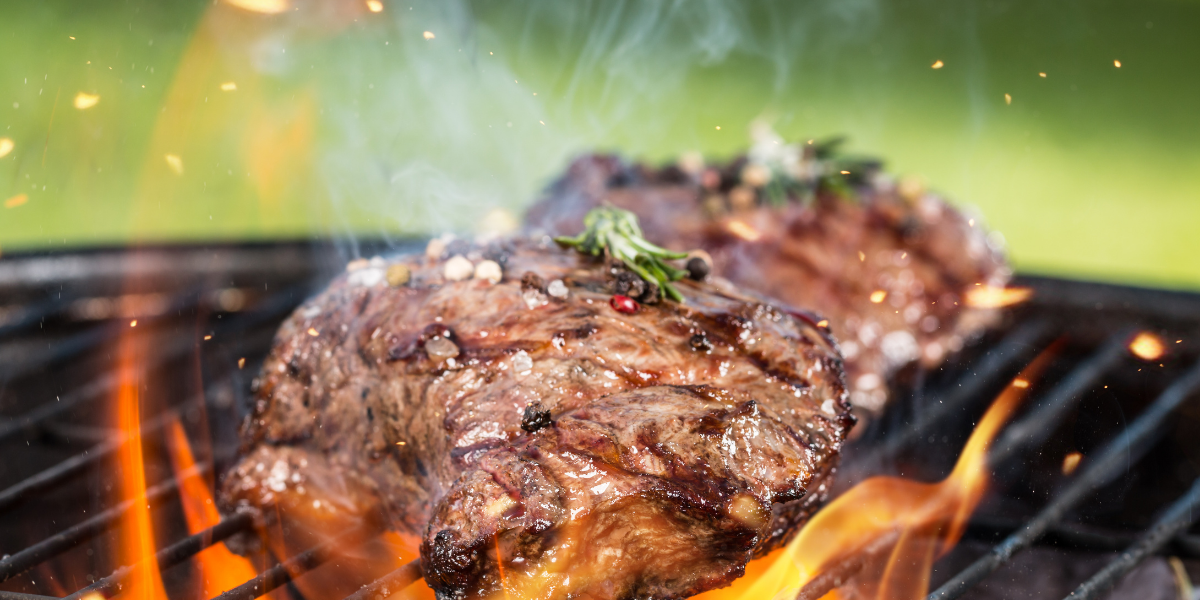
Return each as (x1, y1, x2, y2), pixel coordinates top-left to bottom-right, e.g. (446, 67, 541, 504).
(167, 420, 257, 598)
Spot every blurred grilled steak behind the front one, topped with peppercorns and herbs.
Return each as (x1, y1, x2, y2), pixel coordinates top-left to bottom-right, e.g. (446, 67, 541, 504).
(527, 147, 1010, 414)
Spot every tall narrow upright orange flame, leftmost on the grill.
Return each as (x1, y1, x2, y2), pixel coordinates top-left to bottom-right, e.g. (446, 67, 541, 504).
(116, 331, 167, 600)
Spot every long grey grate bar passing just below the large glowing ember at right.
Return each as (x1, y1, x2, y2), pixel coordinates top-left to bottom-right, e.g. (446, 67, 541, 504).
(928, 355, 1200, 600)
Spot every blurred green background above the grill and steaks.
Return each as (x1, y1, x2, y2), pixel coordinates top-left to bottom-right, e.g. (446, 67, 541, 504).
(0, 0, 1200, 289)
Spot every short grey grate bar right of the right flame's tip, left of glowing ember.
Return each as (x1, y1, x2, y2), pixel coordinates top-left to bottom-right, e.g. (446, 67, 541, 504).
(988, 330, 1133, 466)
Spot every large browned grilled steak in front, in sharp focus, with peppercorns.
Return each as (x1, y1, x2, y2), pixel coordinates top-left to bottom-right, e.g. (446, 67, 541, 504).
(222, 240, 853, 599)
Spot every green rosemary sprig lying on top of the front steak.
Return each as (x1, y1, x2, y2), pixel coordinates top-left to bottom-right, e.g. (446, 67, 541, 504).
(554, 206, 688, 302)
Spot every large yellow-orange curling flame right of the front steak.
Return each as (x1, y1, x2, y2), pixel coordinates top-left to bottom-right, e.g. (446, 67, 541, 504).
(696, 350, 1051, 600)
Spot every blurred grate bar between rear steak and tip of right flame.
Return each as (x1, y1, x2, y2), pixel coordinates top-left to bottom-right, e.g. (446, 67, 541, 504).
(862, 319, 1050, 466)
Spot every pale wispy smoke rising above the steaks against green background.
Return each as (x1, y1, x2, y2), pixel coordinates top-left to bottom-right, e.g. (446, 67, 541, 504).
(243, 0, 880, 248)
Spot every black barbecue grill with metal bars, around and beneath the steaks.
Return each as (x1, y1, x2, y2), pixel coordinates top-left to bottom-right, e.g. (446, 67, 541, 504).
(0, 242, 1200, 600)
